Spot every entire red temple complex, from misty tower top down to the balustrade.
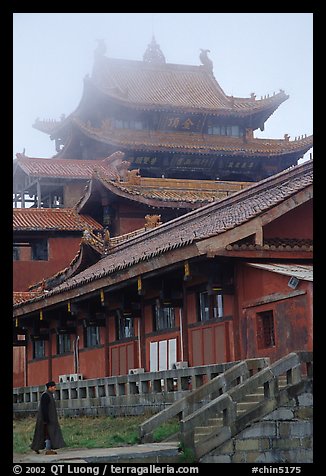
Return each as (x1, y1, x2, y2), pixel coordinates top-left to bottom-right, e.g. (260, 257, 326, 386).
(13, 38, 313, 386)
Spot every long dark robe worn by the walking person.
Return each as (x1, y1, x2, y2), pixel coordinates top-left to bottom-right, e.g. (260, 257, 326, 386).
(31, 390, 66, 451)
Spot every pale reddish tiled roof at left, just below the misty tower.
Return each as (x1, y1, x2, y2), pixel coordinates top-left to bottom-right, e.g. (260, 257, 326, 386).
(14, 154, 118, 179)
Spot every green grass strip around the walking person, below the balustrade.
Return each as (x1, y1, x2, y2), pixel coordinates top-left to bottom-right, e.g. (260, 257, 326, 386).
(13, 415, 178, 454)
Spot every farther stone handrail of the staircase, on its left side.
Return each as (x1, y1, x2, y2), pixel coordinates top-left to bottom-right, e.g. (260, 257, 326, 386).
(140, 358, 269, 442)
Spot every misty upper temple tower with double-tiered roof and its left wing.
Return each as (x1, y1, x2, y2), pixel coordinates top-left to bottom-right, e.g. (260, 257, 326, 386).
(14, 38, 313, 207)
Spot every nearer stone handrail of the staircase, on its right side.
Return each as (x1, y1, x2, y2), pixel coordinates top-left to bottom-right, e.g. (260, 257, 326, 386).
(180, 351, 313, 454)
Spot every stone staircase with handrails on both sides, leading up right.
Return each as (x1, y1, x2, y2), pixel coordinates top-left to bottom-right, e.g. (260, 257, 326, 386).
(140, 352, 313, 461)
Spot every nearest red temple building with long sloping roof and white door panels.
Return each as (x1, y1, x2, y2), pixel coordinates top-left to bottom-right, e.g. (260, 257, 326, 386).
(13, 161, 313, 385)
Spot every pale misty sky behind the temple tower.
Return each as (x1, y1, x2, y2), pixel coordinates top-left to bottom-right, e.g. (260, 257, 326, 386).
(13, 13, 313, 158)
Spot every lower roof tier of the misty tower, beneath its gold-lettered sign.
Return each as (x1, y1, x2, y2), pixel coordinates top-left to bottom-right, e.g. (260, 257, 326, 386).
(72, 117, 313, 157)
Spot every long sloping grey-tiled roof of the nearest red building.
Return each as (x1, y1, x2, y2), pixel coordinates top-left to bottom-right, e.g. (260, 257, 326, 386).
(14, 160, 313, 306)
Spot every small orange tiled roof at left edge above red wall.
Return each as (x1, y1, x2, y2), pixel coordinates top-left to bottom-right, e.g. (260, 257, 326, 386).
(13, 208, 102, 231)
